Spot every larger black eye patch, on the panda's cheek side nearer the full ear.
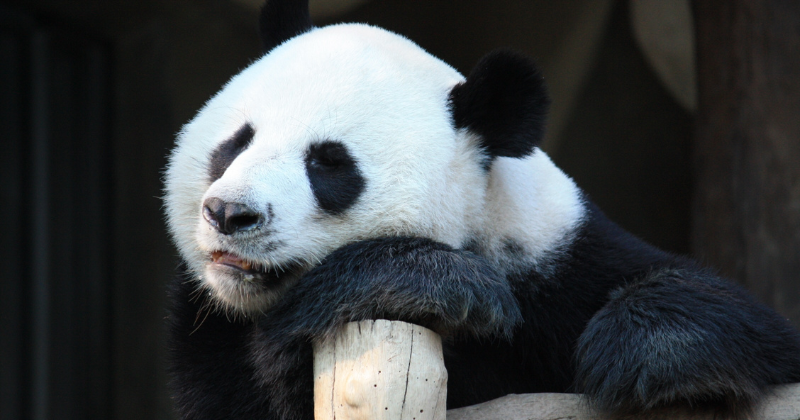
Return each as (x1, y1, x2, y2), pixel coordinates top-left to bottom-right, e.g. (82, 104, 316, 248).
(305, 140, 365, 215)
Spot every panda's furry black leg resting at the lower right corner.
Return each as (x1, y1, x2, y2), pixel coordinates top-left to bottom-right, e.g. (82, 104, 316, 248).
(576, 270, 800, 416)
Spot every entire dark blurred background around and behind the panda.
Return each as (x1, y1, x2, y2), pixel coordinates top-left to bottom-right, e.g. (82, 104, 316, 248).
(0, 0, 800, 420)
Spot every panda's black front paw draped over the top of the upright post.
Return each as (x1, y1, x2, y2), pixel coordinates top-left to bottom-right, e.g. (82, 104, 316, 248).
(256, 237, 521, 337)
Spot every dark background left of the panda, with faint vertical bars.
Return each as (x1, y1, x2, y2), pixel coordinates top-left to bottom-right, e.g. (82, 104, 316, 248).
(0, 1, 259, 420)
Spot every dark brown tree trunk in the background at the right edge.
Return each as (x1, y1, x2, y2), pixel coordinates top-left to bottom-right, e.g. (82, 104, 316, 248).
(692, 0, 800, 326)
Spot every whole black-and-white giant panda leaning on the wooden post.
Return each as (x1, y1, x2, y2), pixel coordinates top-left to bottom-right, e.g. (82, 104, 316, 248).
(165, 0, 800, 420)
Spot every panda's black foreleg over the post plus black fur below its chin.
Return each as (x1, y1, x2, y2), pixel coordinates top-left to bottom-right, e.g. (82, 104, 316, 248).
(169, 238, 520, 419)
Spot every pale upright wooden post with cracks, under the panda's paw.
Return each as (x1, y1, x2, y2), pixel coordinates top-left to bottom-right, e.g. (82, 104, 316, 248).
(314, 320, 447, 420)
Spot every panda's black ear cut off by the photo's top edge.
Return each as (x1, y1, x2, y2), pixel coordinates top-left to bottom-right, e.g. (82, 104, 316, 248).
(258, 0, 314, 53)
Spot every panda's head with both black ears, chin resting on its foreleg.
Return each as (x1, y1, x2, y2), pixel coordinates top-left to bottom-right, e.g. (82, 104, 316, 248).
(165, 1, 547, 314)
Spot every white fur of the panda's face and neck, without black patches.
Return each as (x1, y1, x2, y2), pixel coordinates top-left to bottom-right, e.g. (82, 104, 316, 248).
(165, 24, 582, 312)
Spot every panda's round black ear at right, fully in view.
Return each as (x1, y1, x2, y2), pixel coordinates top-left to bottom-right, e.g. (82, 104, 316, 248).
(450, 50, 550, 158)
